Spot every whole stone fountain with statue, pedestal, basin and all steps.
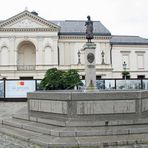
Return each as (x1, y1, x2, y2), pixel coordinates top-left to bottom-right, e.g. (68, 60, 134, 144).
(2, 16, 148, 148)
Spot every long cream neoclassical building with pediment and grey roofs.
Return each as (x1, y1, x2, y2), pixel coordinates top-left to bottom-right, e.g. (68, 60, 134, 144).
(0, 10, 148, 79)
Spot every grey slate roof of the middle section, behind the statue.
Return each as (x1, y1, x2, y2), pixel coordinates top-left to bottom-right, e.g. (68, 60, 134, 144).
(51, 20, 111, 36)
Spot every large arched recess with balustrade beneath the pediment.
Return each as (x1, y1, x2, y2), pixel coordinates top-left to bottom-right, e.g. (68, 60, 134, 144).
(17, 41, 36, 70)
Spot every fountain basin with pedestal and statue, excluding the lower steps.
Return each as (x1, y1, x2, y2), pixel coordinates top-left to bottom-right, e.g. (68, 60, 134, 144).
(28, 16, 148, 126)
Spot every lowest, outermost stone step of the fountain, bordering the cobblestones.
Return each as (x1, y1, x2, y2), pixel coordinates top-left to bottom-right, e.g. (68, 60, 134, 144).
(0, 125, 148, 148)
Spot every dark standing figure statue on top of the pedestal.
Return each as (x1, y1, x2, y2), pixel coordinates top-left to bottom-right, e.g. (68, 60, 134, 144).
(85, 16, 93, 43)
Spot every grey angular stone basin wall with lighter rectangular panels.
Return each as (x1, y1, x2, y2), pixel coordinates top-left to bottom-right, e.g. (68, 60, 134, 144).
(28, 91, 148, 120)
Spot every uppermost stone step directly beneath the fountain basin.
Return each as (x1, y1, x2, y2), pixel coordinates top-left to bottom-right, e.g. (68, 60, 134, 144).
(13, 114, 148, 127)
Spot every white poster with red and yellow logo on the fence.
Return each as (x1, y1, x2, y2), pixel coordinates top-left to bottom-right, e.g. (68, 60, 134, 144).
(5, 80, 35, 98)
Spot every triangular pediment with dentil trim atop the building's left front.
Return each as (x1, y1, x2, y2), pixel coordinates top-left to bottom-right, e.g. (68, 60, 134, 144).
(0, 10, 60, 31)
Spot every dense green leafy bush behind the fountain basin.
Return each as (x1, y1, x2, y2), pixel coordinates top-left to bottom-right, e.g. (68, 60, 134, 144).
(40, 68, 82, 90)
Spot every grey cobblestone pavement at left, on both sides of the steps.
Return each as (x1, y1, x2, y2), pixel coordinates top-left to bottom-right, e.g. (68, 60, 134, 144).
(0, 102, 41, 148)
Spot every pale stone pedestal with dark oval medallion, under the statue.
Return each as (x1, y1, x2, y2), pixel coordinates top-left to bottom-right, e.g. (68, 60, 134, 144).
(83, 42, 96, 91)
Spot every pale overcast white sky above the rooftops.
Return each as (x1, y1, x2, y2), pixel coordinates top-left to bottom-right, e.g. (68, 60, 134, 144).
(0, 0, 148, 38)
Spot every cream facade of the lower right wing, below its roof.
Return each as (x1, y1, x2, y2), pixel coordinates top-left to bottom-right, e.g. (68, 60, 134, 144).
(112, 45, 148, 78)
